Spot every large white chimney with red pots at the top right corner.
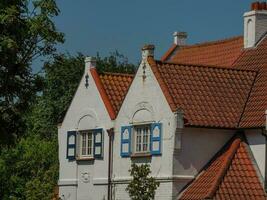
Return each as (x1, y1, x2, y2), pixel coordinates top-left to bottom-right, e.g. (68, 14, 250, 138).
(244, 1, 267, 48)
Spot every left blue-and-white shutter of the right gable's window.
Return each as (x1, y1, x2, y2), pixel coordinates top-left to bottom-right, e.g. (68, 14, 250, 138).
(121, 126, 132, 157)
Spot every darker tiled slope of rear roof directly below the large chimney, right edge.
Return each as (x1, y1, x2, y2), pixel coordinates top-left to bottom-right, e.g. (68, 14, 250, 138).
(233, 36, 267, 128)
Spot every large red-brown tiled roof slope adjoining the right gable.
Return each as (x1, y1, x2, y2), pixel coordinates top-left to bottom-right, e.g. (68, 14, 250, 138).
(148, 57, 256, 128)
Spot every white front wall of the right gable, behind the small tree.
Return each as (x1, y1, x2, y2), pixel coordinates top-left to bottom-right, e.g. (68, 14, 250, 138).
(113, 57, 178, 199)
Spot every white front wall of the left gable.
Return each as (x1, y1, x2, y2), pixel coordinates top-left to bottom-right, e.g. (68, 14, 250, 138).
(58, 65, 113, 200)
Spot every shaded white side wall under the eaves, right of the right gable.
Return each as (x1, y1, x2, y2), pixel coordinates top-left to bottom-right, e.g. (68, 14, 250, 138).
(173, 128, 235, 176)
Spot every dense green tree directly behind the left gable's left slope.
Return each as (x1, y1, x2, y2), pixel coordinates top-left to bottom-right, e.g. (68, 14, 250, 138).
(27, 54, 84, 139)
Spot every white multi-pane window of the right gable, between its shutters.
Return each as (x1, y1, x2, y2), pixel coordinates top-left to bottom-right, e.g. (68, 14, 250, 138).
(132, 124, 151, 154)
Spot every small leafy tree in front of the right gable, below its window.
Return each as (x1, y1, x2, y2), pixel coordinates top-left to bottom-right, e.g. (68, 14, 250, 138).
(126, 164, 159, 200)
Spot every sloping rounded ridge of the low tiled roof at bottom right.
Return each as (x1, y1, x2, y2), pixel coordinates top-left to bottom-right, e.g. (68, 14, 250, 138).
(206, 133, 242, 199)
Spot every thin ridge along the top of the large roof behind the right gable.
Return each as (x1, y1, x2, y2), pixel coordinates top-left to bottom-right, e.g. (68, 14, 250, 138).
(158, 60, 258, 72)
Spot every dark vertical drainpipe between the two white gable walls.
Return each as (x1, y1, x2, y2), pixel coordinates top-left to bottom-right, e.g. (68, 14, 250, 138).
(107, 128, 114, 200)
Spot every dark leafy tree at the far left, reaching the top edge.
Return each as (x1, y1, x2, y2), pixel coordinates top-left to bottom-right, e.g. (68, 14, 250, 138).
(0, 0, 63, 145)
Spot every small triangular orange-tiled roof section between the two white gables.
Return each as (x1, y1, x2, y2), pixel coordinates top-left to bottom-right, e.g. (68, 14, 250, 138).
(99, 73, 134, 115)
